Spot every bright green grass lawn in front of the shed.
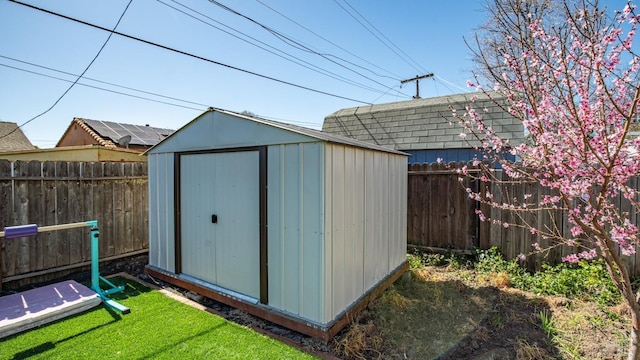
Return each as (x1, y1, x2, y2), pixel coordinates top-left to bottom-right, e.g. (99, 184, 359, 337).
(0, 278, 313, 359)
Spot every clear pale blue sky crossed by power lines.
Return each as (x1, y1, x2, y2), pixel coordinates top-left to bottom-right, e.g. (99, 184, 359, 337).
(0, 0, 625, 147)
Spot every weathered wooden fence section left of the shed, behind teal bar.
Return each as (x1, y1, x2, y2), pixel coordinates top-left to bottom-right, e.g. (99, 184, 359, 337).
(0, 160, 148, 289)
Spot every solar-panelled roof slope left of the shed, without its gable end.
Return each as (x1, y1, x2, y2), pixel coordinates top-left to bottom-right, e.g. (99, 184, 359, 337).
(82, 119, 175, 146)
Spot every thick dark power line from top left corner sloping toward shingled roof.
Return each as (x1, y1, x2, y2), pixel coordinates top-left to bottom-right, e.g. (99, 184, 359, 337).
(9, 0, 370, 105)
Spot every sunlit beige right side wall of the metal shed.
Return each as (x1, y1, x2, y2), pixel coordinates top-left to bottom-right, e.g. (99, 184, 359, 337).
(324, 144, 407, 322)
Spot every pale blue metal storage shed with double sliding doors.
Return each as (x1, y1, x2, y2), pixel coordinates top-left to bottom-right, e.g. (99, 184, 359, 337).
(147, 109, 407, 340)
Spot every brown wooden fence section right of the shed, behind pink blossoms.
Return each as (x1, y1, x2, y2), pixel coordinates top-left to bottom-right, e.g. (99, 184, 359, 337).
(407, 164, 640, 275)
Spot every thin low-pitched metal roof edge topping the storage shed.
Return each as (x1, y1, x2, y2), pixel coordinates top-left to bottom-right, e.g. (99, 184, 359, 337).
(147, 108, 408, 155)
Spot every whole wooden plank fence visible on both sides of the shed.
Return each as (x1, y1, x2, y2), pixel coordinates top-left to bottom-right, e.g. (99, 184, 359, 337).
(0, 160, 640, 289)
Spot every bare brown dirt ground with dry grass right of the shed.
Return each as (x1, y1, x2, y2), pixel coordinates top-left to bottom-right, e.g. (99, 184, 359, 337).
(333, 267, 630, 360)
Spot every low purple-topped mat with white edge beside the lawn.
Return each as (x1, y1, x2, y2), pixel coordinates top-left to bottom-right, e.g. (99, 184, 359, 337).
(0, 280, 102, 338)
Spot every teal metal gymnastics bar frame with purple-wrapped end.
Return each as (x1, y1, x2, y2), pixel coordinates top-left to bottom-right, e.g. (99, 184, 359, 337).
(0, 220, 131, 314)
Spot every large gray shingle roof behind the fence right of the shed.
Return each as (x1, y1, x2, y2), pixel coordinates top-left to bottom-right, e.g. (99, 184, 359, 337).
(322, 93, 524, 151)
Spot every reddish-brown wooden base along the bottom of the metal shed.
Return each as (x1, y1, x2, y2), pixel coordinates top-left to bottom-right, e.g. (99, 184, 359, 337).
(145, 261, 409, 342)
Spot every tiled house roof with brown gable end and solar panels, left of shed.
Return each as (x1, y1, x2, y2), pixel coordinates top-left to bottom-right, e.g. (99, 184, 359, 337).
(56, 118, 175, 148)
